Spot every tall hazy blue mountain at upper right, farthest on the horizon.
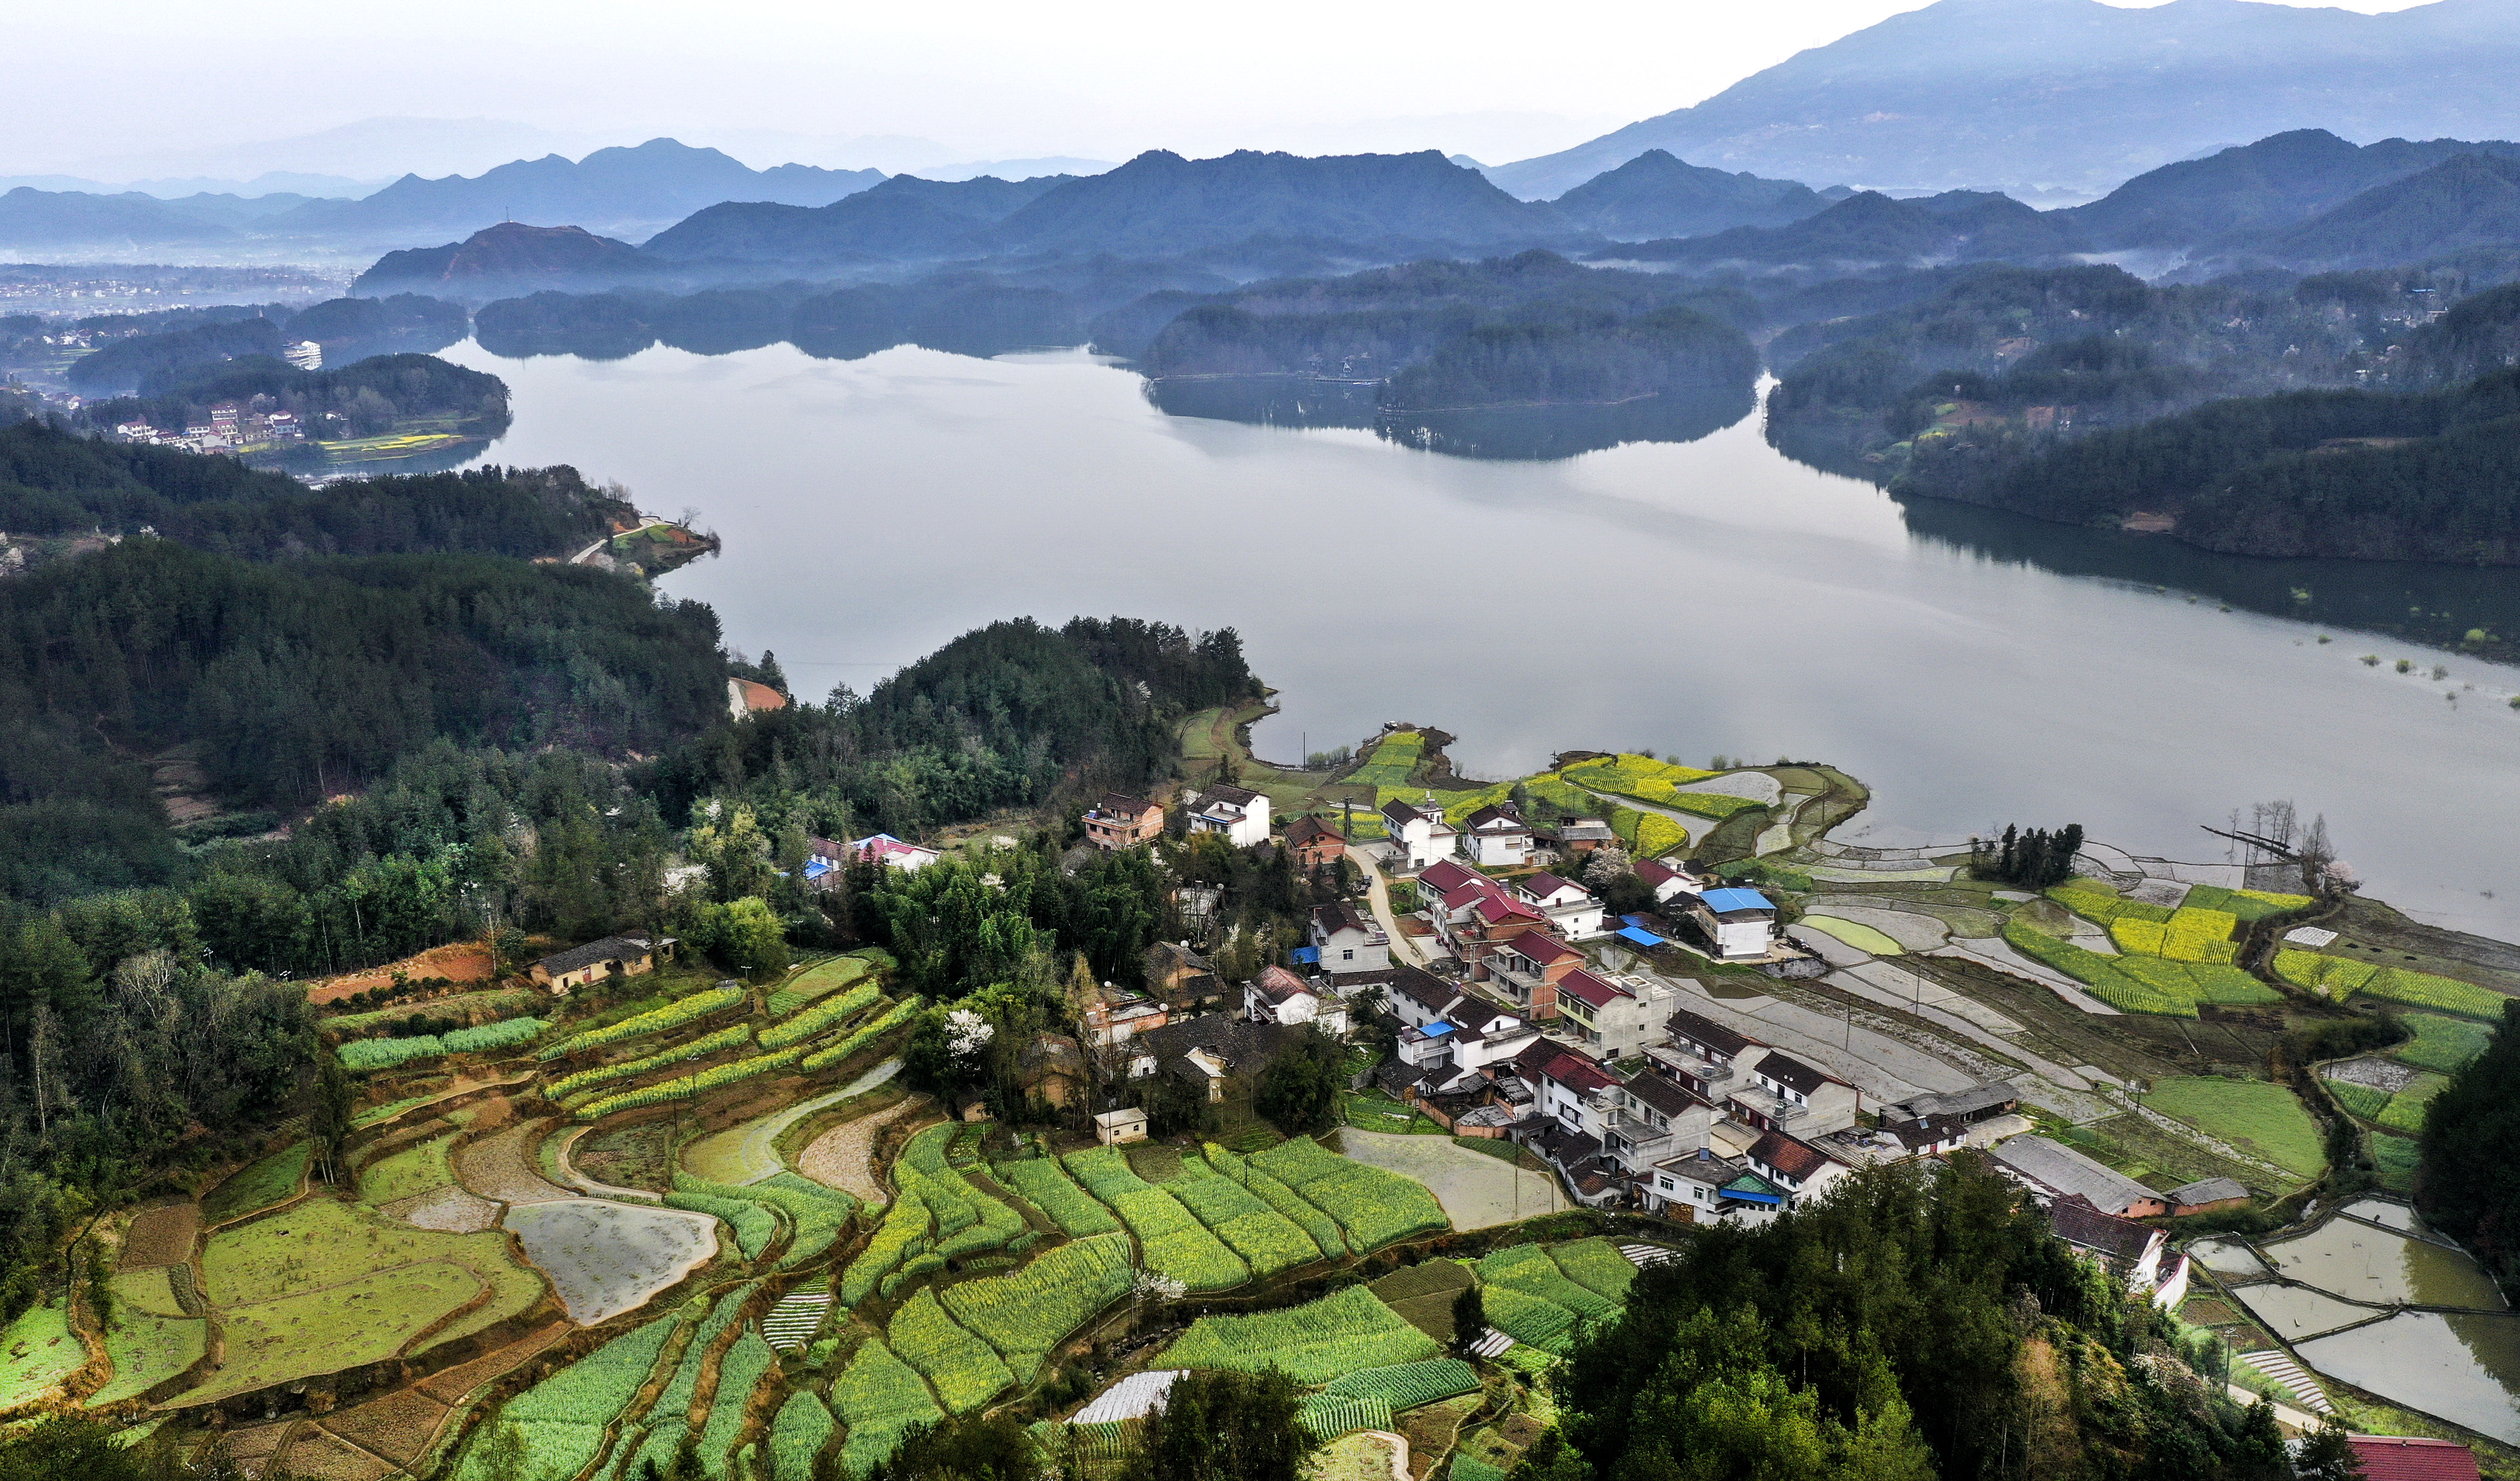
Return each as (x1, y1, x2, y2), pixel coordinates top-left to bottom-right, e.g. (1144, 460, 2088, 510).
(1487, 0, 2520, 199)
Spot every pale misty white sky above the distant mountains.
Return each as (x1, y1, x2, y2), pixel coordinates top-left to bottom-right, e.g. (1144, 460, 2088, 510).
(0, 0, 2412, 179)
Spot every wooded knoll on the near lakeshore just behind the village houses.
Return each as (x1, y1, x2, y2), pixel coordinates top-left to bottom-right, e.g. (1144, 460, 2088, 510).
(647, 617, 1260, 836)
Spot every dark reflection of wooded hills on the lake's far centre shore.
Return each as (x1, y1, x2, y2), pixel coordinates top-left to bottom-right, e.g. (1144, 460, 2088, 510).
(1147, 375, 1756, 461)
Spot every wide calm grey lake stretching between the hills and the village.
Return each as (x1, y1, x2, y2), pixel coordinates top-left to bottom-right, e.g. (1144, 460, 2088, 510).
(446, 343, 2520, 937)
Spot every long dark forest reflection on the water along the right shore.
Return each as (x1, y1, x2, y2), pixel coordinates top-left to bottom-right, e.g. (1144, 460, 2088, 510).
(1897, 496, 2520, 660)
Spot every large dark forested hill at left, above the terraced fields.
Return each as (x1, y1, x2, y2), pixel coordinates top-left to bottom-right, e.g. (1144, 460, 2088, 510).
(0, 539, 726, 902)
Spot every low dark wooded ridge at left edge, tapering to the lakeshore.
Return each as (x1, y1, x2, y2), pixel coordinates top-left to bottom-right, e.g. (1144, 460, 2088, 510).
(0, 421, 635, 559)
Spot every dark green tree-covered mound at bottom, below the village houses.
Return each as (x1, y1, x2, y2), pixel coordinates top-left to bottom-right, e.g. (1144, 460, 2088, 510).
(1514, 1151, 2293, 1481)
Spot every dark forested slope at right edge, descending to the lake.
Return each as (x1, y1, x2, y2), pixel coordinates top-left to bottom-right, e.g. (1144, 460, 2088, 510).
(1892, 370, 2520, 566)
